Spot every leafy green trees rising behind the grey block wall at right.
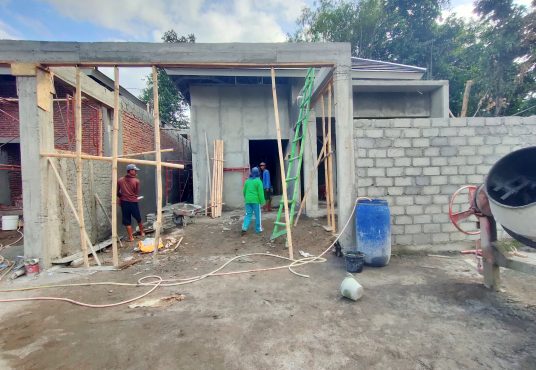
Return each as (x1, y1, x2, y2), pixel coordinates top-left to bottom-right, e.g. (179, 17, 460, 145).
(289, 0, 536, 116)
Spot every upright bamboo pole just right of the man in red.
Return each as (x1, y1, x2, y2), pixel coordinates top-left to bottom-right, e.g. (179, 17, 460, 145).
(153, 66, 162, 260)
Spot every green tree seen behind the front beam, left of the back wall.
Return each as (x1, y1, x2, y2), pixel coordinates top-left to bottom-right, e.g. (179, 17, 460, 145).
(140, 30, 195, 128)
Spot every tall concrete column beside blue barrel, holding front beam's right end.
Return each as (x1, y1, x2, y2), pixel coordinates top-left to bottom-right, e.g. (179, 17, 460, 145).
(334, 63, 355, 250)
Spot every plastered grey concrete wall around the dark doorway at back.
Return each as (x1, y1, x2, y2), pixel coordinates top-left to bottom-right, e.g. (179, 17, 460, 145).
(190, 85, 290, 208)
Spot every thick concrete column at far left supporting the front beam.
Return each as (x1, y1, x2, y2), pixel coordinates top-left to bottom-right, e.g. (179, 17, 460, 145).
(17, 70, 61, 267)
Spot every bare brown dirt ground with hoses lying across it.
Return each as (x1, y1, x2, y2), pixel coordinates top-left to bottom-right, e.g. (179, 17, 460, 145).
(0, 214, 536, 369)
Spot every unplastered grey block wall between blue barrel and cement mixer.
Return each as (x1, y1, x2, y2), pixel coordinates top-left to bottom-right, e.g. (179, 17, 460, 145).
(354, 116, 536, 245)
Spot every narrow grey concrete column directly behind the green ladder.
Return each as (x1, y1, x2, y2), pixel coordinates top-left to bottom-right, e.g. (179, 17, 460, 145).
(303, 109, 318, 217)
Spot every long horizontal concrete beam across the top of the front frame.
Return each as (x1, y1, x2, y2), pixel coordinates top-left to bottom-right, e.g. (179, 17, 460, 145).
(0, 40, 350, 67)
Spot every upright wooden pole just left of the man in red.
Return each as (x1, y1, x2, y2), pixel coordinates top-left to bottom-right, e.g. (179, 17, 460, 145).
(112, 66, 120, 267)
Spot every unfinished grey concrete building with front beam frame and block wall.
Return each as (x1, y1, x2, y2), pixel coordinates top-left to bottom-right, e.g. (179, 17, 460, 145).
(0, 41, 536, 266)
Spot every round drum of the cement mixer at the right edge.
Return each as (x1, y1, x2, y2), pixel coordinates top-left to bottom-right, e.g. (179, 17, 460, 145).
(485, 147, 536, 247)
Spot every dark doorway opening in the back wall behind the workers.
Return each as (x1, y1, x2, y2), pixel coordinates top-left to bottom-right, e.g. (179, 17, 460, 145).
(249, 140, 288, 195)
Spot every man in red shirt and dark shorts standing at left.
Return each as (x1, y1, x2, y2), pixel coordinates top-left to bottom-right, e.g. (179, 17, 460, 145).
(117, 164, 145, 242)
